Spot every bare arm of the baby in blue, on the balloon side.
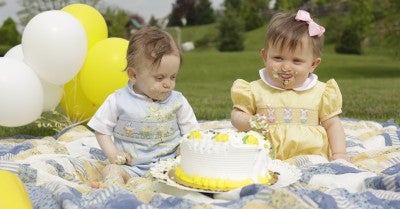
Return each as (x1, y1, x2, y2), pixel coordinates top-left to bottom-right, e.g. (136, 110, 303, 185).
(95, 131, 132, 165)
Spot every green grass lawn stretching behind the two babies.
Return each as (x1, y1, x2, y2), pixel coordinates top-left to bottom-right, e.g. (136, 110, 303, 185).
(0, 24, 400, 137)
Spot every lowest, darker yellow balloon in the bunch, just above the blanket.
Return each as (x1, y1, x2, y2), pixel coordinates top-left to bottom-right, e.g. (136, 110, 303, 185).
(60, 74, 99, 122)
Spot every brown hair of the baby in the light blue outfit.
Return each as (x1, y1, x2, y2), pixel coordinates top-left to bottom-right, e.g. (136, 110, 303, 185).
(126, 26, 182, 69)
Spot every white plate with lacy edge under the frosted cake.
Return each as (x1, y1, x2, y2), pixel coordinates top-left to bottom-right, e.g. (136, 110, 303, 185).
(150, 157, 301, 193)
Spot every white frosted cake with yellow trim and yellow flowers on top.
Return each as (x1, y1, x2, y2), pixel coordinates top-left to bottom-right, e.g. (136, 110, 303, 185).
(175, 130, 276, 191)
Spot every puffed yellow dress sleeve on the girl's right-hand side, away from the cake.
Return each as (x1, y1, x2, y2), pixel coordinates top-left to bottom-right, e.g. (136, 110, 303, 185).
(319, 79, 342, 122)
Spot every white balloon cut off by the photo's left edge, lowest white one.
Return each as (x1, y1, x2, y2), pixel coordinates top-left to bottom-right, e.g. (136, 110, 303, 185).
(0, 57, 43, 127)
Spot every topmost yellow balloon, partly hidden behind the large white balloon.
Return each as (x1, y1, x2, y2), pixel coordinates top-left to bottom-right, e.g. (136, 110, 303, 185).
(61, 3, 108, 49)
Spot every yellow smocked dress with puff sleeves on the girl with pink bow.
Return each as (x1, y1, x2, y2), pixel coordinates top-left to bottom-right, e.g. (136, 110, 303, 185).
(231, 76, 342, 160)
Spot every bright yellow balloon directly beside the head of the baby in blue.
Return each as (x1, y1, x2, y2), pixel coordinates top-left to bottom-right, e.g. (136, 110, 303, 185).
(78, 38, 128, 106)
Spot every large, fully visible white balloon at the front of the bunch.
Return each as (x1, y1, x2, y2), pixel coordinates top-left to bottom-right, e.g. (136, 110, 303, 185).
(21, 10, 87, 85)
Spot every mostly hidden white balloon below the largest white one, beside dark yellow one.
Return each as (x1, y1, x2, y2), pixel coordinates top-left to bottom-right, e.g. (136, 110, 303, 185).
(40, 80, 64, 112)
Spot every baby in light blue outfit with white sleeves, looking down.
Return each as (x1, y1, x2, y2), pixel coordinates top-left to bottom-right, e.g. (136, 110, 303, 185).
(88, 27, 199, 185)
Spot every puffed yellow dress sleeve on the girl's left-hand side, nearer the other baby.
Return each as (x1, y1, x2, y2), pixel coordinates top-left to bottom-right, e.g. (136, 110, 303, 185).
(231, 79, 256, 115)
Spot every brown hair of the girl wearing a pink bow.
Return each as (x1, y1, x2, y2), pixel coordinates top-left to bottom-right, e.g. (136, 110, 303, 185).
(265, 12, 324, 57)
